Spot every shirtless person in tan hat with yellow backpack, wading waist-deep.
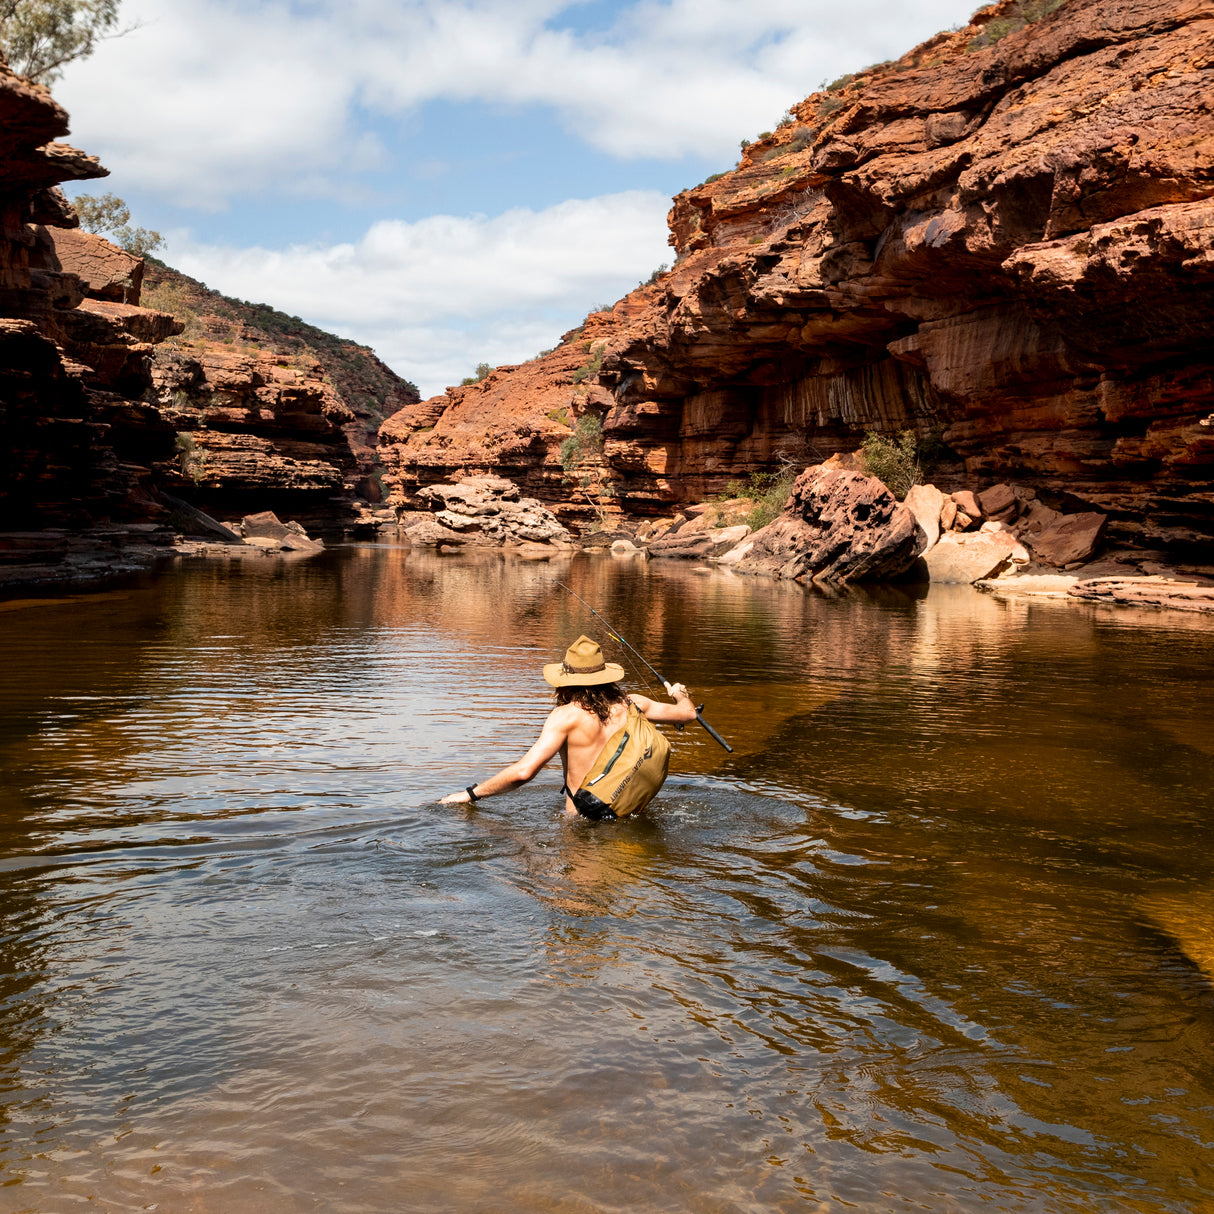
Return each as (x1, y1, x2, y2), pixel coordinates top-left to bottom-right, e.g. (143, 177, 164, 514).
(441, 636, 696, 818)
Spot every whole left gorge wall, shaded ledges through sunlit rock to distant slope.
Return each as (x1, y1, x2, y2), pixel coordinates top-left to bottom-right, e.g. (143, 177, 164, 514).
(0, 67, 416, 565)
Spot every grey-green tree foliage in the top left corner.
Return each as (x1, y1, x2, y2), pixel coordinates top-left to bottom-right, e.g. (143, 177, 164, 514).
(0, 0, 119, 84)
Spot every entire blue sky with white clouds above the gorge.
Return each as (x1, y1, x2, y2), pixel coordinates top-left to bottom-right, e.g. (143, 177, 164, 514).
(53, 0, 975, 397)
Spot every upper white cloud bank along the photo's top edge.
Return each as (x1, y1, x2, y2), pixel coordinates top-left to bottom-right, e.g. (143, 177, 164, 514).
(57, 0, 972, 206)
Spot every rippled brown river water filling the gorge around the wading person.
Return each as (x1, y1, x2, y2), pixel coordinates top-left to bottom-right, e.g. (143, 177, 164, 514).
(0, 548, 1214, 1214)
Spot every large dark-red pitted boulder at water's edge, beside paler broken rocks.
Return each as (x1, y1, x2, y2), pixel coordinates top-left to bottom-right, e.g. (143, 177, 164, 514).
(736, 465, 921, 585)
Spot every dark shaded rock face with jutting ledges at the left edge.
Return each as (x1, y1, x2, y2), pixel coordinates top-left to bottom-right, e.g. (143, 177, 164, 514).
(0, 67, 178, 531)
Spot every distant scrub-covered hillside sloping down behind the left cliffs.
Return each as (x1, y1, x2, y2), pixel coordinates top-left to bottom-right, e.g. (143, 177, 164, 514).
(140, 257, 420, 427)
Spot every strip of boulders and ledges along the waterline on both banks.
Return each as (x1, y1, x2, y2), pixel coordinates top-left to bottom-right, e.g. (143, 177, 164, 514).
(7, 460, 1214, 613)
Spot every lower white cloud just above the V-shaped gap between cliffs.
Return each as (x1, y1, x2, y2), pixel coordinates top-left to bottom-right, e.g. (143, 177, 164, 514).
(170, 191, 670, 396)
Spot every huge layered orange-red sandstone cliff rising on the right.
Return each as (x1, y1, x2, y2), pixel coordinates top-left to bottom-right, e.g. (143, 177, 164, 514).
(381, 0, 1214, 549)
